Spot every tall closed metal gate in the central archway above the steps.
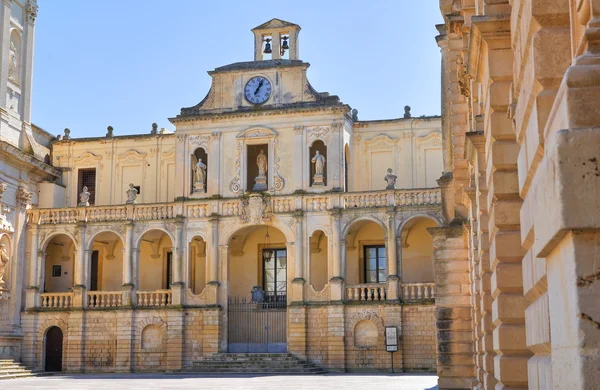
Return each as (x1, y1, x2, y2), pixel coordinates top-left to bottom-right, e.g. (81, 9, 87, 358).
(227, 295, 287, 353)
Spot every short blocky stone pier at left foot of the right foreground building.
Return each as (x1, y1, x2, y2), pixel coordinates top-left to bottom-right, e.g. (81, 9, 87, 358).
(427, 225, 475, 389)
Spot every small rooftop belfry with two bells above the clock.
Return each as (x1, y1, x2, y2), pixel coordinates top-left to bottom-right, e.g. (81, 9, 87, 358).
(252, 18, 300, 61)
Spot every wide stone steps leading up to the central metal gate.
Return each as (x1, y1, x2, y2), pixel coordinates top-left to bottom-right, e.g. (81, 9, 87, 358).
(190, 353, 327, 374)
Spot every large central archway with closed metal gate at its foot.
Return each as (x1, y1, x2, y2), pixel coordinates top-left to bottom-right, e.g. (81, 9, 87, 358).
(227, 225, 293, 353)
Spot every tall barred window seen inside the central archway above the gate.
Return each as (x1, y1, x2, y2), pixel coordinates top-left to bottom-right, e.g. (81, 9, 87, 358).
(263, 248, 287, 303)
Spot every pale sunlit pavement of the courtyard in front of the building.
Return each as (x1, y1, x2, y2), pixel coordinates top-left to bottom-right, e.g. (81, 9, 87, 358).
(5, 374, 437, 390)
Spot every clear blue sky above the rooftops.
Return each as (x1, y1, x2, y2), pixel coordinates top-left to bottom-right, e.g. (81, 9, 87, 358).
(32, 0, 441, 137)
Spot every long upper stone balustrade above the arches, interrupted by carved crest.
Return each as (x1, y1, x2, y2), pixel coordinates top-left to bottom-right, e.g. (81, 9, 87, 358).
(29, 188, 442, 225)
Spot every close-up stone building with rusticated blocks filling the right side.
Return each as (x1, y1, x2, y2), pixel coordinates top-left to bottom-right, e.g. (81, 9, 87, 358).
(430, 0, 600, 389)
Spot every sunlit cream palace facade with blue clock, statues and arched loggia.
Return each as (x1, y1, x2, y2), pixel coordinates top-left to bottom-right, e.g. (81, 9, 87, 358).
(0, 15, 445, 372)
